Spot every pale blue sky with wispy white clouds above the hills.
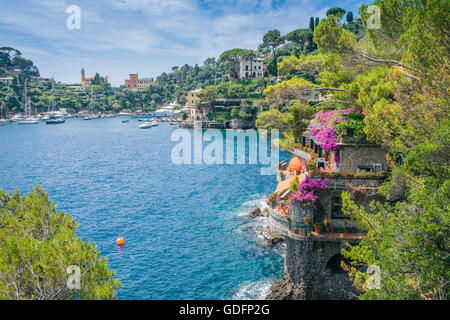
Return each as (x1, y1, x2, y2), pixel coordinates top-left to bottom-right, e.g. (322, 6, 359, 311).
(0, 0, 368, 86)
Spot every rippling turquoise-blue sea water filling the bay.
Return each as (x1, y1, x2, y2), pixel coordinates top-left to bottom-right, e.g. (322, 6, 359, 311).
(0, 117, 287, 299)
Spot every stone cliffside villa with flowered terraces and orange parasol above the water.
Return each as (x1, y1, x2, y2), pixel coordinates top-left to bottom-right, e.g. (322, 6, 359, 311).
(267, 110, 388, 299)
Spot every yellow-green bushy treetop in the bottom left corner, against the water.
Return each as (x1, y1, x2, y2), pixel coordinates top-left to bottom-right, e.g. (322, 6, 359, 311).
(0, 186, 120, 300)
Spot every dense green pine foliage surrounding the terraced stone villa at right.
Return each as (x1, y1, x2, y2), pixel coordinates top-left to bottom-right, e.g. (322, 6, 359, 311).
(257, 0, 450, 299)
